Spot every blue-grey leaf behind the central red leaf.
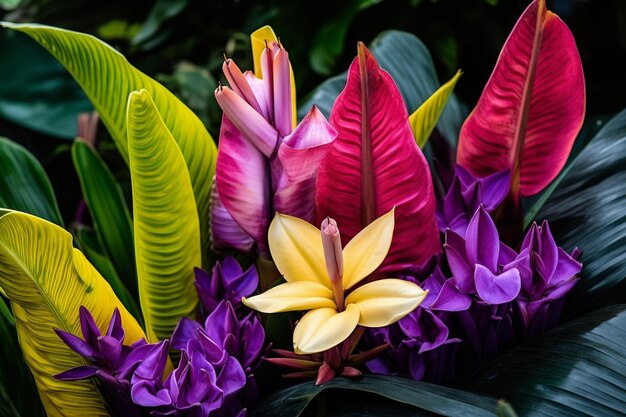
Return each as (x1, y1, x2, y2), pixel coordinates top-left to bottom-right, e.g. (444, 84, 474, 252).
(298, 30, 466, 144)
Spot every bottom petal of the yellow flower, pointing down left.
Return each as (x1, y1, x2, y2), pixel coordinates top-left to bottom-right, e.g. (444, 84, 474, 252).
(293, 304, 359, 355)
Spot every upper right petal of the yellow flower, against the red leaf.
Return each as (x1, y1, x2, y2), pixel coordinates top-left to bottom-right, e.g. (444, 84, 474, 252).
(339, 209, 395, 290)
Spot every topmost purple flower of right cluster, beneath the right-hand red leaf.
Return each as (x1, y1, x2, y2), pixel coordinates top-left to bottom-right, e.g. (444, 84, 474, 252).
(437, 165, 511, 237)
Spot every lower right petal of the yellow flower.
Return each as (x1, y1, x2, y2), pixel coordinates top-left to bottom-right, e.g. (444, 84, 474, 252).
(346, 279, 428, 327)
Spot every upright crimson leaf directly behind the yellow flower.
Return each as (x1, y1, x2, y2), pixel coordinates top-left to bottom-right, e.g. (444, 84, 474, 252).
(315, 44, 441, 272)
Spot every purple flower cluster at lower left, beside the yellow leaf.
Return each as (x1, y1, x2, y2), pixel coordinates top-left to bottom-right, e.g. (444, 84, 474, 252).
(56, 258, 265, 417)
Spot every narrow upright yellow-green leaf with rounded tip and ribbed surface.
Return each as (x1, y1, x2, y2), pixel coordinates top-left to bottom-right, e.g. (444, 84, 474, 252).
(127, 90, 201, 342)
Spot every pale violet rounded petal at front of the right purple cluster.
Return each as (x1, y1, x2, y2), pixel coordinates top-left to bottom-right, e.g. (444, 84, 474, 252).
(474, 265, 521, 305)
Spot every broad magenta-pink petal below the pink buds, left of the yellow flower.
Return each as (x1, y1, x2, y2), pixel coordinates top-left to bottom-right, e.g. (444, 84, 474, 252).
(216, 116, 270, 254)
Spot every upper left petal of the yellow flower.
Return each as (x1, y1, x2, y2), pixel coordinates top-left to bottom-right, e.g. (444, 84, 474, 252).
(268, 213, 331, 289)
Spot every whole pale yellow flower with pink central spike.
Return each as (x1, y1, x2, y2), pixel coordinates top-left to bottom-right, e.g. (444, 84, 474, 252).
(242, 209, 427, 354)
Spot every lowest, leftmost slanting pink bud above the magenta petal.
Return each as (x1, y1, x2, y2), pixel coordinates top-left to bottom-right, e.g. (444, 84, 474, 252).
(215, 86, 278, 158)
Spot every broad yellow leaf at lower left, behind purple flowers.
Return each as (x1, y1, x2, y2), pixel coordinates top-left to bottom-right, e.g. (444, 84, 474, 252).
(0, 211, 145, 417)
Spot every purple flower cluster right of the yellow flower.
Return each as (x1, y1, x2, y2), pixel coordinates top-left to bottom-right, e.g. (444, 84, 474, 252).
(368, 166, 582, 376)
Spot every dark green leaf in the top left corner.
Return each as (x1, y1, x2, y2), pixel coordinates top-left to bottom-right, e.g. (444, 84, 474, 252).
(0, 30, 93, 139)
